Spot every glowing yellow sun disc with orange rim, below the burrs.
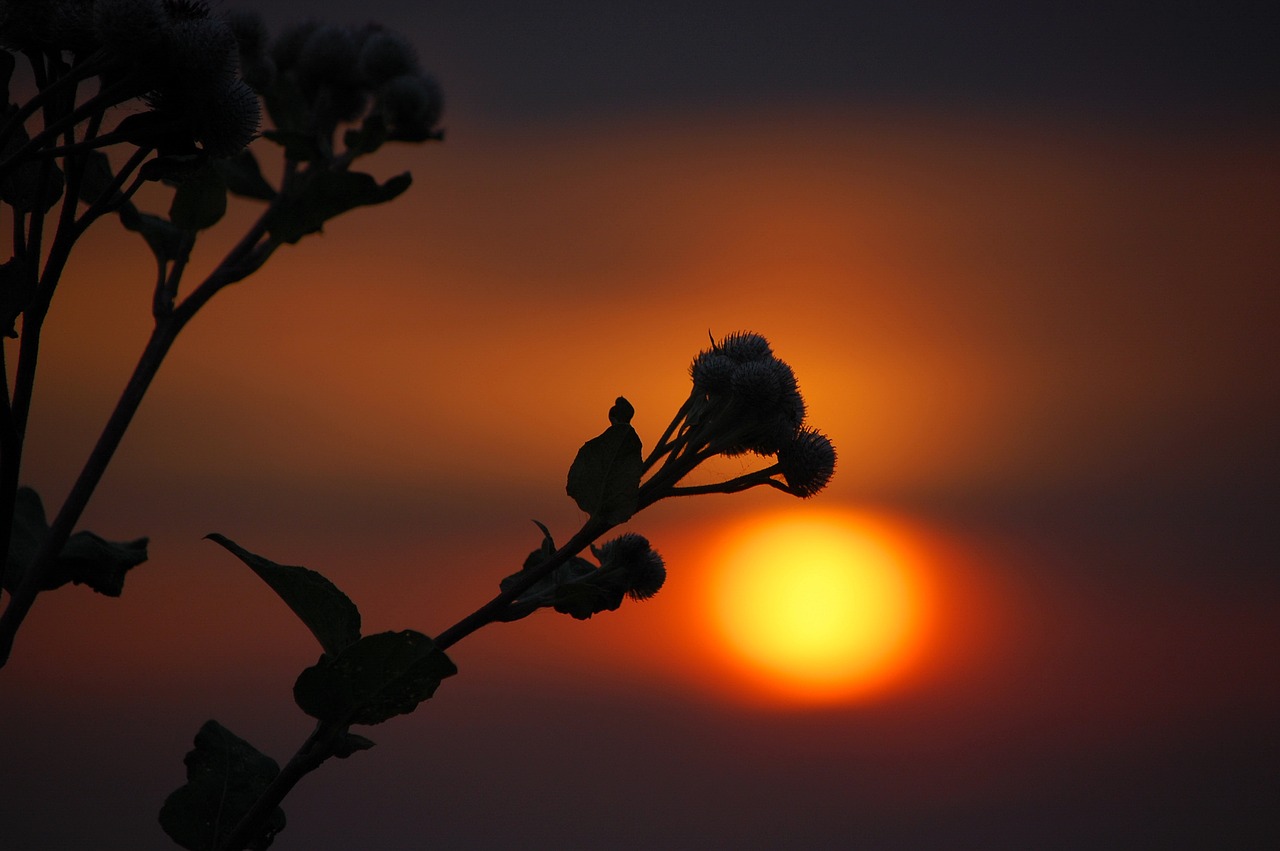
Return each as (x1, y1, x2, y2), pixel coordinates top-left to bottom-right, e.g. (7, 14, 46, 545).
(709, 512, 924, 701)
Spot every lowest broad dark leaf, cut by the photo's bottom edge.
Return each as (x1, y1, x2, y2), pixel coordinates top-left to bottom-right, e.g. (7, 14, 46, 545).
(160, 720, 284, 851)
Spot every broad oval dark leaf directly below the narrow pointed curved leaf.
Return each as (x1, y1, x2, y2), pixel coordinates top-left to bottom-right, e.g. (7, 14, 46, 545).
(293, 630, 457, 724)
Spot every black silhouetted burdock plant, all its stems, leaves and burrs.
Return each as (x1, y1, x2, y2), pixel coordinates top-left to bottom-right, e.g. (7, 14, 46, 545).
(0, 0, 836, 851)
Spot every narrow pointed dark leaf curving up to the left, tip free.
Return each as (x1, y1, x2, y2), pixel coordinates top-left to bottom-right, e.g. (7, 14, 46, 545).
(205, 532, 360, 655)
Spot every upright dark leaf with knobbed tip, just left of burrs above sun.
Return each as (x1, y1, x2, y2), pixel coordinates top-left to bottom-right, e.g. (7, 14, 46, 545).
(564, 397, 644, 525)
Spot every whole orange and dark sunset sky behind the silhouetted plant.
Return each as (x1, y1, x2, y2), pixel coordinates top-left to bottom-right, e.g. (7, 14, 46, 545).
(0, 0, 1280, 851)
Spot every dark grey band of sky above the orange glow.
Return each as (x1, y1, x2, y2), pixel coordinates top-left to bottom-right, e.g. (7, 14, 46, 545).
(259, 0, 1280, 122)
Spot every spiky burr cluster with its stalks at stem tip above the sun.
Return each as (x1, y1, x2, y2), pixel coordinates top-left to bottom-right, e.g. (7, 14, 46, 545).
(640, 331, 836, 505)
